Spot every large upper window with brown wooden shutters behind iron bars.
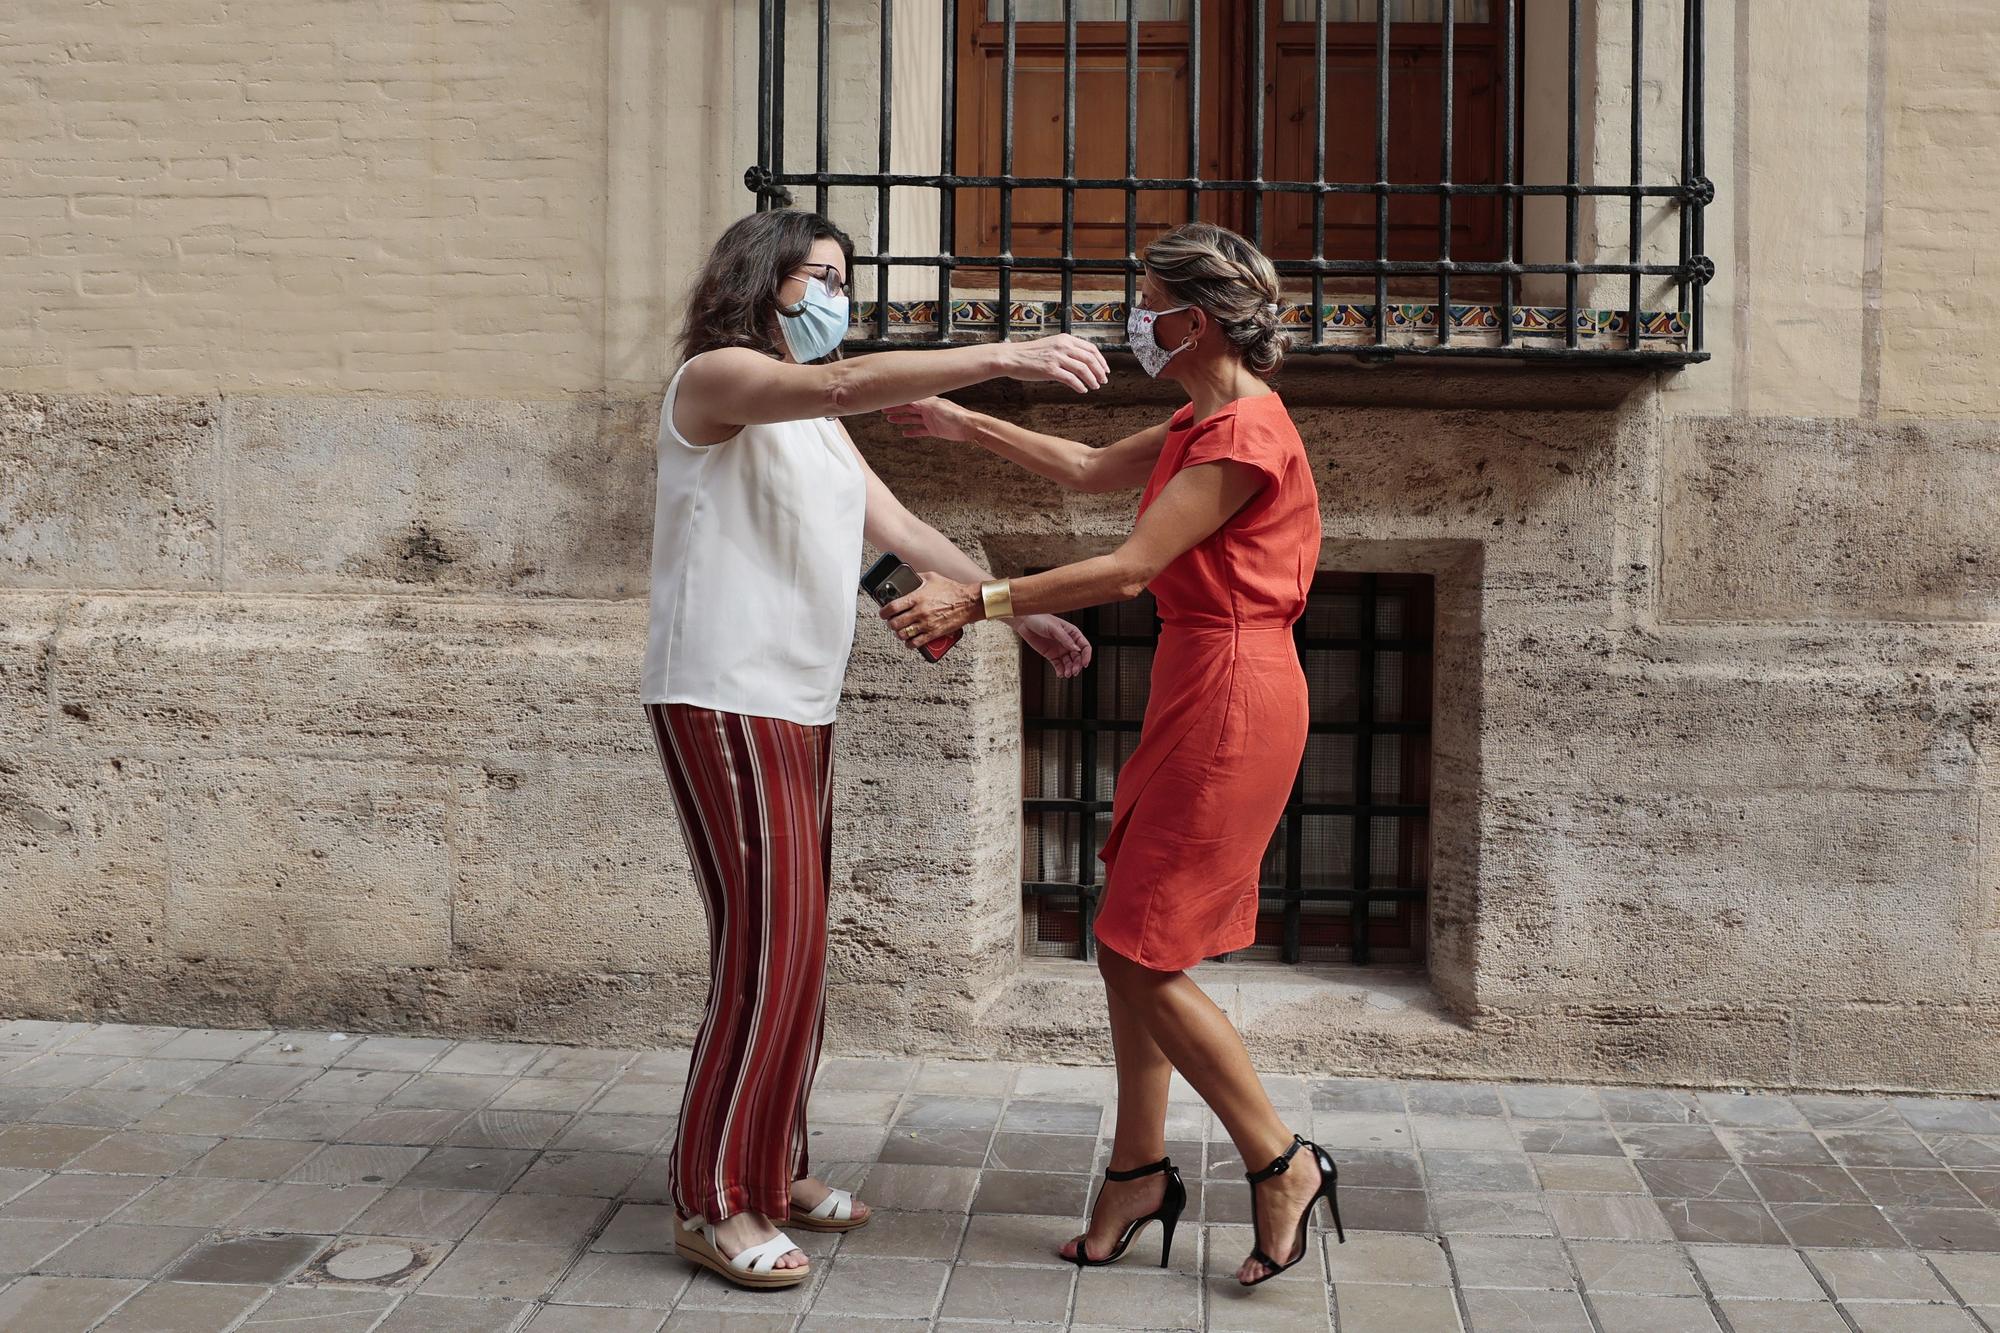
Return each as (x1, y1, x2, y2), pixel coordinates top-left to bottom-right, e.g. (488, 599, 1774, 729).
(746, 0, 1714, 364)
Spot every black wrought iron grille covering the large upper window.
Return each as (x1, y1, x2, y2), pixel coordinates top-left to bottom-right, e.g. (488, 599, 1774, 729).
(744, 0, 1714, 364)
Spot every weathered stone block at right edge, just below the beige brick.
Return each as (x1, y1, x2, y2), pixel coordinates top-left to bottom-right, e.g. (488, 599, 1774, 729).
(1662, 418, 2000, 620)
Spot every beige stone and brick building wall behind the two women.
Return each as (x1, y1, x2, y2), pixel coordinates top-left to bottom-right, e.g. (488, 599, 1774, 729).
(0, 0, 2000, 1091)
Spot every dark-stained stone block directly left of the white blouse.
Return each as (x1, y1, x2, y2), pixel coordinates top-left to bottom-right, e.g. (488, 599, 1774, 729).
(222, 394, 658, 596)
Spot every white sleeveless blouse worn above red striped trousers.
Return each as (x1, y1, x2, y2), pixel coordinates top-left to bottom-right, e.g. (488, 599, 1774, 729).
(640, 360, 868, 727)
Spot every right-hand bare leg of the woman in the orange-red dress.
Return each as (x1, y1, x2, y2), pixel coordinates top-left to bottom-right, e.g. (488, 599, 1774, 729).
(1098, 949, 1320, 1281)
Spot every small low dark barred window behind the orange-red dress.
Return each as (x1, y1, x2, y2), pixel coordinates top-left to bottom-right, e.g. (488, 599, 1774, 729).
(1022, 572, 1432, 965)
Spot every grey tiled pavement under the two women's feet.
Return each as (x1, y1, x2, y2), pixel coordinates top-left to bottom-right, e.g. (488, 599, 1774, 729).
(0, 1023, 2000, 1333)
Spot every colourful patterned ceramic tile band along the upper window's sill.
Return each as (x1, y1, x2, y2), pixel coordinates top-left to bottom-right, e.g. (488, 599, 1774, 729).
(854, 296, 1688, 346)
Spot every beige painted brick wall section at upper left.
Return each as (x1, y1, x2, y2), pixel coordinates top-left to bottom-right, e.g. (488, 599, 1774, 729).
(0, 0, 606, 394)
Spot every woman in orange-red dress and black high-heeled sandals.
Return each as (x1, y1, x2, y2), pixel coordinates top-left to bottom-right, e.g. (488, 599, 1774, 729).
(882, 222, 1340, 1285)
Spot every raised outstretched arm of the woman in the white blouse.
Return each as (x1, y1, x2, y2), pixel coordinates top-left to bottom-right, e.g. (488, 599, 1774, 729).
(674, 334, 1110, 444)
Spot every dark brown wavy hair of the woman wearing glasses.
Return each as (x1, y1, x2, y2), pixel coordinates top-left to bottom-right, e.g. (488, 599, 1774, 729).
(678, 208, 854, 360)
